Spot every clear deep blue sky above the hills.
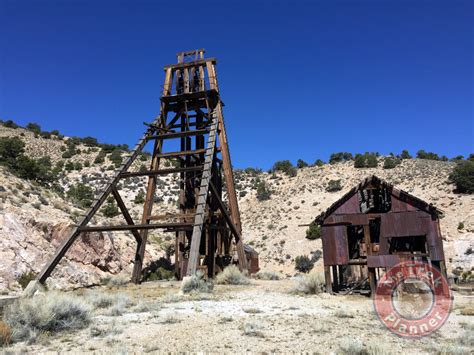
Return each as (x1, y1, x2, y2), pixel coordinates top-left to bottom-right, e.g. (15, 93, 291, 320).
(0, 0, 474, 169)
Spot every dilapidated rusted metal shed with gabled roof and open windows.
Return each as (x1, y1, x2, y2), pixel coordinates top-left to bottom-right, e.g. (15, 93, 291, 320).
(313, 176, 446, 293)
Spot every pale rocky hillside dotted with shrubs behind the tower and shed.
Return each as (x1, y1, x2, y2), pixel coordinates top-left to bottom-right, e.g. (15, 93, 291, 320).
(0, 125, 474, 292)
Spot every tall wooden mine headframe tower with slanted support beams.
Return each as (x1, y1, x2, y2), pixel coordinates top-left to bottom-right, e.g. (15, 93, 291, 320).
(32, 49, 247, 283)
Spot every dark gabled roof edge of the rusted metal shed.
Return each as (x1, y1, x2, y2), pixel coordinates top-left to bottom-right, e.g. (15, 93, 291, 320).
(313, 175, 443, 224)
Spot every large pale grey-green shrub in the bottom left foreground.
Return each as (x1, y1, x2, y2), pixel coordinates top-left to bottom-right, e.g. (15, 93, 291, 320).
(4, 292, 91, 341)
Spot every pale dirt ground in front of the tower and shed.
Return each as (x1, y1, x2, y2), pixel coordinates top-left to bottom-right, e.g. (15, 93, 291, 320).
(0, 279, 474, 354)
